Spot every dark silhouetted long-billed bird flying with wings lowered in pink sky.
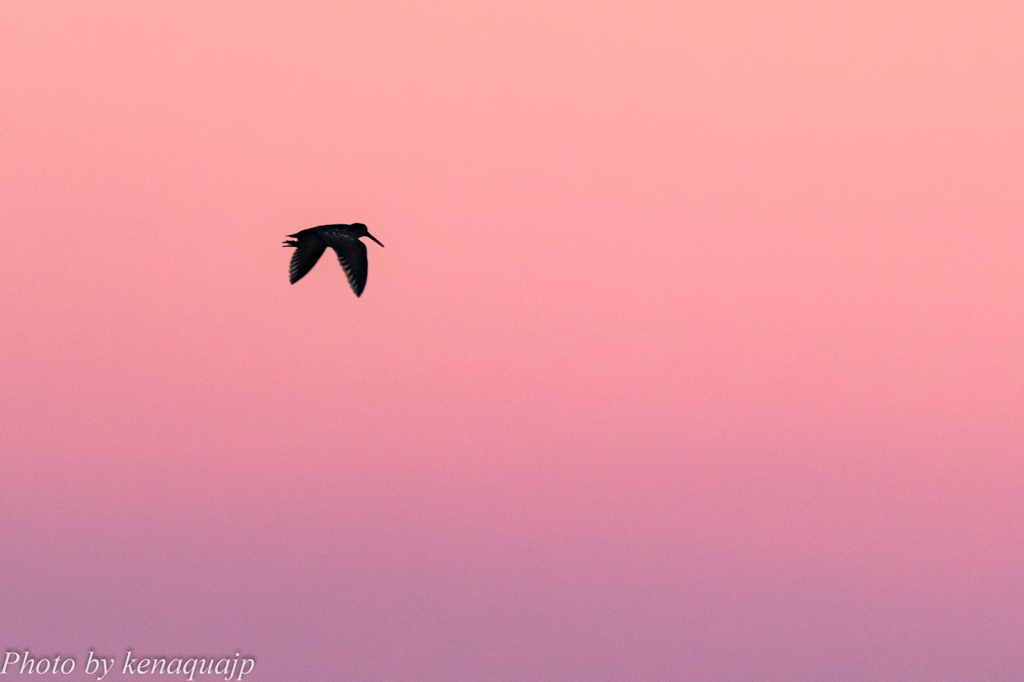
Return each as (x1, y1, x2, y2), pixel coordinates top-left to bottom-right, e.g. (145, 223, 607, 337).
(284, 222, 384, 296)
